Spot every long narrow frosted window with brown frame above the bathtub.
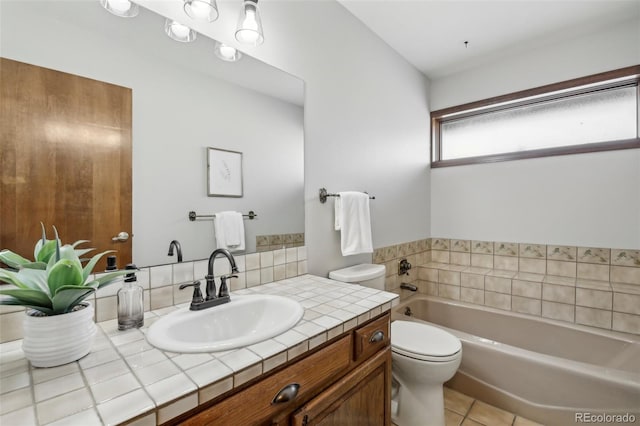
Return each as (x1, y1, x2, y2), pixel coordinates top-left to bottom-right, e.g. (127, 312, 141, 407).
(431, 66, 640, 167)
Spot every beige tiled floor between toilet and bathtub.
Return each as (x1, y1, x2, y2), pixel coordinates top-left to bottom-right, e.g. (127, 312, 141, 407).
(444, 387, 541, 426)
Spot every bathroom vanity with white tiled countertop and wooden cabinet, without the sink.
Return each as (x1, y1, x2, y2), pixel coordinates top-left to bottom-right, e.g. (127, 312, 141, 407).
(0, 275, 398, 426)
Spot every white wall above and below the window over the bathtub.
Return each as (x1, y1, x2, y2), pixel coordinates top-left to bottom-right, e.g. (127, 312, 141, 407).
(430, 20, 640, 249)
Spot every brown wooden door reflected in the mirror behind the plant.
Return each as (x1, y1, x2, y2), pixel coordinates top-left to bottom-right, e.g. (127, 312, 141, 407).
(0, 58, 132, 271)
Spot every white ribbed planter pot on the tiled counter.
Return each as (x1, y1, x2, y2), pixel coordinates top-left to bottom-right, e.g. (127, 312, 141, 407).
(22, 302, 96, 367)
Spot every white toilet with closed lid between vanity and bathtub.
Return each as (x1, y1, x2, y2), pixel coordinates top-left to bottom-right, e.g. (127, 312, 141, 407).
(329, 264, 462, 426)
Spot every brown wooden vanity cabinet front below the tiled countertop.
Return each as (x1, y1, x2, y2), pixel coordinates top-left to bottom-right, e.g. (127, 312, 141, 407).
(181, 313, 391, 426)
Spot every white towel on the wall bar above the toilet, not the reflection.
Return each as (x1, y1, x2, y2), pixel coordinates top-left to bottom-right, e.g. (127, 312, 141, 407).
(335, 191, 373, 256)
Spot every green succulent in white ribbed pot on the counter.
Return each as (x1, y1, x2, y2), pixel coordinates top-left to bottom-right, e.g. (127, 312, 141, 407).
(0, 224, 131, 367)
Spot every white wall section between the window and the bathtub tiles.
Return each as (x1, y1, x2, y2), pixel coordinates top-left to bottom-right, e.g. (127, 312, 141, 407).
(431, 150, 640, 248)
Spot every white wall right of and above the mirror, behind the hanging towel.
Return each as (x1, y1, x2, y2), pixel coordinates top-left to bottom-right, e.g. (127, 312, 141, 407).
(142, 0, 430, 275)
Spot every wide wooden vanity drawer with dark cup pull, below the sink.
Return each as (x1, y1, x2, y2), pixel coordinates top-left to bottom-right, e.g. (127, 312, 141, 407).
(183, 335, 352, 426)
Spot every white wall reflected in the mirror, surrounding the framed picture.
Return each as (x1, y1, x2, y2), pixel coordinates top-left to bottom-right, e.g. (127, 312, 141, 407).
(1, 2, 304, 266)
